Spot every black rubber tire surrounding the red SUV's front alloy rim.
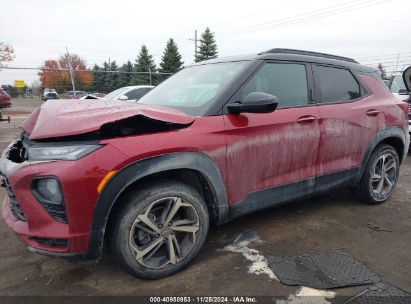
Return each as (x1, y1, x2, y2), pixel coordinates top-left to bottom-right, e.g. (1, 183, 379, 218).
(110, 181, 209, 279)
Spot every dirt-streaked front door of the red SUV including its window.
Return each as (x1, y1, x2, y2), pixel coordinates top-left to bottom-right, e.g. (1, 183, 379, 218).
(224, 62, 320, 205)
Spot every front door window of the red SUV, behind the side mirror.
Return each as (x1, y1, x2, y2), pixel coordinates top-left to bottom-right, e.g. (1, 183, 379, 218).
(241, 63, 308, 107)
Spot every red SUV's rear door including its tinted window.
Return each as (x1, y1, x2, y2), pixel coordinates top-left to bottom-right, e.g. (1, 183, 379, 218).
(313, 65, 383, 188)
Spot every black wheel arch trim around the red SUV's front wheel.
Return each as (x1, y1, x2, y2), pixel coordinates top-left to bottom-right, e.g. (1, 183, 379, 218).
(86, 152, 228, 259)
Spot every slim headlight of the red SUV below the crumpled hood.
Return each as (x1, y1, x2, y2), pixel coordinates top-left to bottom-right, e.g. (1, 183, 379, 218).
(28, 145, 101, 161)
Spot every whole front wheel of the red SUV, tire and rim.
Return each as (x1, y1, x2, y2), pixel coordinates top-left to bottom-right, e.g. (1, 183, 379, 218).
(109, 180, 209, 279)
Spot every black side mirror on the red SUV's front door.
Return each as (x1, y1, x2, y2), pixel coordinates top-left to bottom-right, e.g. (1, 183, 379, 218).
(227, 92, 278, 114)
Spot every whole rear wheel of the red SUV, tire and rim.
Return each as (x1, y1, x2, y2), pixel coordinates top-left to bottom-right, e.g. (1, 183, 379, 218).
(353, 144, 400, 204)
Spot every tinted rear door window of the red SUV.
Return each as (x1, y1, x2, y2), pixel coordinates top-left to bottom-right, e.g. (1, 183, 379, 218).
(317, 66, 361, 102)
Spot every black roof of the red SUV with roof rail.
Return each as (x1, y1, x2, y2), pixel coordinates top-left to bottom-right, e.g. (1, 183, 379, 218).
(193, 48, 376, 73)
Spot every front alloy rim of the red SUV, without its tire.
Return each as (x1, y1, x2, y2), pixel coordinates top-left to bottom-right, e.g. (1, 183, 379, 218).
(129, 197, 200, 269)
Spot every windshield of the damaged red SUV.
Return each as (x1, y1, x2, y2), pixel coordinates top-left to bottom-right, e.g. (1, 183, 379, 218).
(139, 61, 247, 116)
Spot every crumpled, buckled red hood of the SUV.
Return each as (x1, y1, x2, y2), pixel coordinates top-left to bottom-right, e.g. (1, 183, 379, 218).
(21, 99, 195, 140)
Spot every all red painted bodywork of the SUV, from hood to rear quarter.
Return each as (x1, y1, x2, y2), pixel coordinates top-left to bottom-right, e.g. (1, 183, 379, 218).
(3, 72, 408, 252)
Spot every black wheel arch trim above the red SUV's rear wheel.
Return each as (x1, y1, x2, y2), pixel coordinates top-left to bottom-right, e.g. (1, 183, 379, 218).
(356, 127, 409, 184)
